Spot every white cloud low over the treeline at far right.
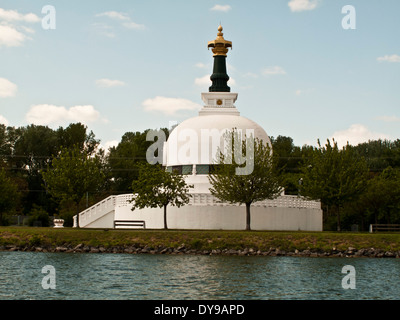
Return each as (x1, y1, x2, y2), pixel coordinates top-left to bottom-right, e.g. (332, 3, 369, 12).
(331, 124, 390, 148)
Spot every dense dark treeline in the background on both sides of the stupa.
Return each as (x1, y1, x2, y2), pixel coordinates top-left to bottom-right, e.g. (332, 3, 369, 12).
(0, 123, 400, 230)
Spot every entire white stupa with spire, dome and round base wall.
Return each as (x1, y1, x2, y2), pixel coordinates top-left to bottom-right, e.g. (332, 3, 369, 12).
(74, 26, 322, 231)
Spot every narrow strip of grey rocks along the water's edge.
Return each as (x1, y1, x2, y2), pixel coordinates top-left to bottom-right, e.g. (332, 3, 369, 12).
(0, 243, 400, 258)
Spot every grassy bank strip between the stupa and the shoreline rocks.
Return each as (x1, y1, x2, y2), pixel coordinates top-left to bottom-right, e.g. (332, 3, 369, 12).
(0, 227, 400, 252)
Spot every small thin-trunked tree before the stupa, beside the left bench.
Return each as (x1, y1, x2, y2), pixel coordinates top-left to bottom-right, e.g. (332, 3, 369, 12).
(131, 162, 193, 229)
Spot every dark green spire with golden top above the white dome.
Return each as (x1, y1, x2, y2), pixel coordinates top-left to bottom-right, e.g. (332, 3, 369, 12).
(208, 26, 232, 92)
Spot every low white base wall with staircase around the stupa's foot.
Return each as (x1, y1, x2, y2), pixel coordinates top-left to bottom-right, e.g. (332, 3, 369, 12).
(76, 194, 322, 231)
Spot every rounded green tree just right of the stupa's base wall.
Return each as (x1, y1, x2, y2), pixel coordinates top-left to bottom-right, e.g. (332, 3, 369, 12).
(301, 140, 368, 231)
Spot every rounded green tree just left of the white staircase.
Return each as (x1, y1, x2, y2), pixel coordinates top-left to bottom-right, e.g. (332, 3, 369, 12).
(42, 146, 105, 227)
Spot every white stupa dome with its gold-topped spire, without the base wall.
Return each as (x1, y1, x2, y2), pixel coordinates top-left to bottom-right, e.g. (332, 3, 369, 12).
(163, 26, 271, 193)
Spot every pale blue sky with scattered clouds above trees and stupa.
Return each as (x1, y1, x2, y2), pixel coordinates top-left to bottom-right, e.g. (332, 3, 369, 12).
(0, 0, 400, 146)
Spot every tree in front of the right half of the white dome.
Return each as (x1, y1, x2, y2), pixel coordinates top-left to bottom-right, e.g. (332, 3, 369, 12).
(208, 130, 282, 230)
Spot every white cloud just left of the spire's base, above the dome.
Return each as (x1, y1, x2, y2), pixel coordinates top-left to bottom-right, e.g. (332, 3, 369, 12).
(142, 96, 201, 115)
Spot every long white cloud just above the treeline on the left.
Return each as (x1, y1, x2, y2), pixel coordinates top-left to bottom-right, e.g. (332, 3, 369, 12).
(25, 104, 106, 125)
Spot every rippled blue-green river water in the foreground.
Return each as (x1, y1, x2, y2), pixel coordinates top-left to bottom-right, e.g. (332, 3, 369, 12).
(0, 252, 400, 300)
